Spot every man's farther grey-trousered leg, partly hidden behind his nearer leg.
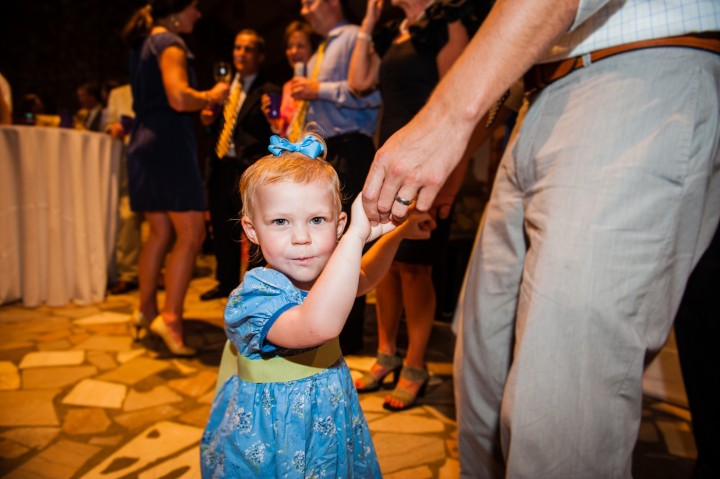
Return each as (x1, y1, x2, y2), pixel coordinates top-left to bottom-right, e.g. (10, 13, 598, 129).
(453, 118, 526, 479)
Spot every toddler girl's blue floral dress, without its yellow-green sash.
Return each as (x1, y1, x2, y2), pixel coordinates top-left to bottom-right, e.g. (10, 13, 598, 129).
(200, 268, 382, 479)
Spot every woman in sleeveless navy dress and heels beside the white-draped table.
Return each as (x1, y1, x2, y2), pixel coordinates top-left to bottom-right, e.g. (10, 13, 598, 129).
(125, 0, 228, 356)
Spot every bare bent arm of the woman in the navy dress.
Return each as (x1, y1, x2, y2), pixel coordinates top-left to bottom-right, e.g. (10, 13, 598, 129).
(159, 46, 229, 112)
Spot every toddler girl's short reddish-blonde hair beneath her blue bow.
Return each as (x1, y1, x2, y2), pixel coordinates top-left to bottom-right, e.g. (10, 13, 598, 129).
(240, 131, 342, 218)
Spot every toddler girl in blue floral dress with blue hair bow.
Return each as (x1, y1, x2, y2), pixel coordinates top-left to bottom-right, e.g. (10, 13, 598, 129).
(201, 134, 433, 478)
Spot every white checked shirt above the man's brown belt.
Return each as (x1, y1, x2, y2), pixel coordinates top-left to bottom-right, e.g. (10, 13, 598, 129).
(542, 0, 720, 63)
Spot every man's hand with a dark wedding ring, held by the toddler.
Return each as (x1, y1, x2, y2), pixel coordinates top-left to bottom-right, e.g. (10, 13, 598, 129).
(362, 106, 472, 225)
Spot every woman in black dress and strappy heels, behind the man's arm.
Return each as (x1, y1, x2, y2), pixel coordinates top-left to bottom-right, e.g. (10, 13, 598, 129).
(348, 0, 479, 411)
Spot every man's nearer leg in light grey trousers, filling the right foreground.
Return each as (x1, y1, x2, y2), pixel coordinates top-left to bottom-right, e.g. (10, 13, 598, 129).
(498, 49, 720, 478)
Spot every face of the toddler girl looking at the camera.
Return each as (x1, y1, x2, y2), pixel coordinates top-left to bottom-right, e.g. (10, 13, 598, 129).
(242, 181, 347, 291)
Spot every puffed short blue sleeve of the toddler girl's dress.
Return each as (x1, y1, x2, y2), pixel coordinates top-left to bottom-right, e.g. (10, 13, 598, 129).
(225, 268, 306, 359)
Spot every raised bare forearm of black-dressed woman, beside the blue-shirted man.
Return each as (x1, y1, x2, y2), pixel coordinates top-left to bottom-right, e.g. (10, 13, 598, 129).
(348, 0, 383, 94)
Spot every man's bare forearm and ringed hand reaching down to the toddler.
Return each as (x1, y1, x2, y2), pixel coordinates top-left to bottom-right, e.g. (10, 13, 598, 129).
(363, 0, 579, 224)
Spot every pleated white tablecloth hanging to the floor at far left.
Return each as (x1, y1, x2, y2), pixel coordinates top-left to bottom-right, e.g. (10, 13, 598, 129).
(0, 126, 121, 306)
